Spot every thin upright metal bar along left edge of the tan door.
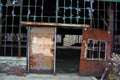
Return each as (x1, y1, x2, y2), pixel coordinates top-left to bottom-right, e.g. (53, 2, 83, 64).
(27, 26, 30, 73)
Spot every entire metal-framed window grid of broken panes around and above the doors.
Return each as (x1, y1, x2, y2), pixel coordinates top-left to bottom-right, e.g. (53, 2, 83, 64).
(0, 0, 120, 56)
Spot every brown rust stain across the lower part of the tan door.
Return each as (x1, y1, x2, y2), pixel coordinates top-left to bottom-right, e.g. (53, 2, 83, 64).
(30, 54, 53, 70)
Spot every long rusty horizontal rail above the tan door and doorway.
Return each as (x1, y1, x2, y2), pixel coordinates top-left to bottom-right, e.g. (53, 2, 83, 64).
(21, 21, 90, 28)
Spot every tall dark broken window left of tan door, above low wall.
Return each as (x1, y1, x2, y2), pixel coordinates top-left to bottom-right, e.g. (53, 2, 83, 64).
(0, 0, 27, 57)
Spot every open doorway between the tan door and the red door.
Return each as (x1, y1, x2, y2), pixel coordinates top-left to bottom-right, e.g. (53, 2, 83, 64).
(56, 28, 82, 74)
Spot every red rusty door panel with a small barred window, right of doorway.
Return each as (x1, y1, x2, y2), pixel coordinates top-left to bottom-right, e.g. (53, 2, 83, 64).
(79, 29, 111, 75)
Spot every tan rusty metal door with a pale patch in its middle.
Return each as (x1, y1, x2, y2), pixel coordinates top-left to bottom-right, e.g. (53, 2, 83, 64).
(30, 27, 54, 73)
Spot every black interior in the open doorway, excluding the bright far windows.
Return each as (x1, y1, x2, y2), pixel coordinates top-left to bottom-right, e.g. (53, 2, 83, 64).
(56, 28, 82, 73)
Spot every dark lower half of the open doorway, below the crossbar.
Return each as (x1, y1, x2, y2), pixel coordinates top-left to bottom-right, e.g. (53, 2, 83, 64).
(56, 49, 80, 73)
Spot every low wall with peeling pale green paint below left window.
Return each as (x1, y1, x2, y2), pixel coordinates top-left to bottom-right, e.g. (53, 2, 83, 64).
(0, 57, 26, 72)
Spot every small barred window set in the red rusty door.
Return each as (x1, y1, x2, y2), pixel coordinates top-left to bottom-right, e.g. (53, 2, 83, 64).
(86, 39, 106, 60)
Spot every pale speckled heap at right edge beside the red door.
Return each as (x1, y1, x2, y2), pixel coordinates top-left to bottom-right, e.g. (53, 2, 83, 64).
(111, 53, 120, 75)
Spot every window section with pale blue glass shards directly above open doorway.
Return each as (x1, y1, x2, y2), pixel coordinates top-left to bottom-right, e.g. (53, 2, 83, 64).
(57, 0, 93, 24)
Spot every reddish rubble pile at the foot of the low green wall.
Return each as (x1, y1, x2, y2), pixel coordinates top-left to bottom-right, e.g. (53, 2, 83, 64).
(7, 66, 26, 77)
